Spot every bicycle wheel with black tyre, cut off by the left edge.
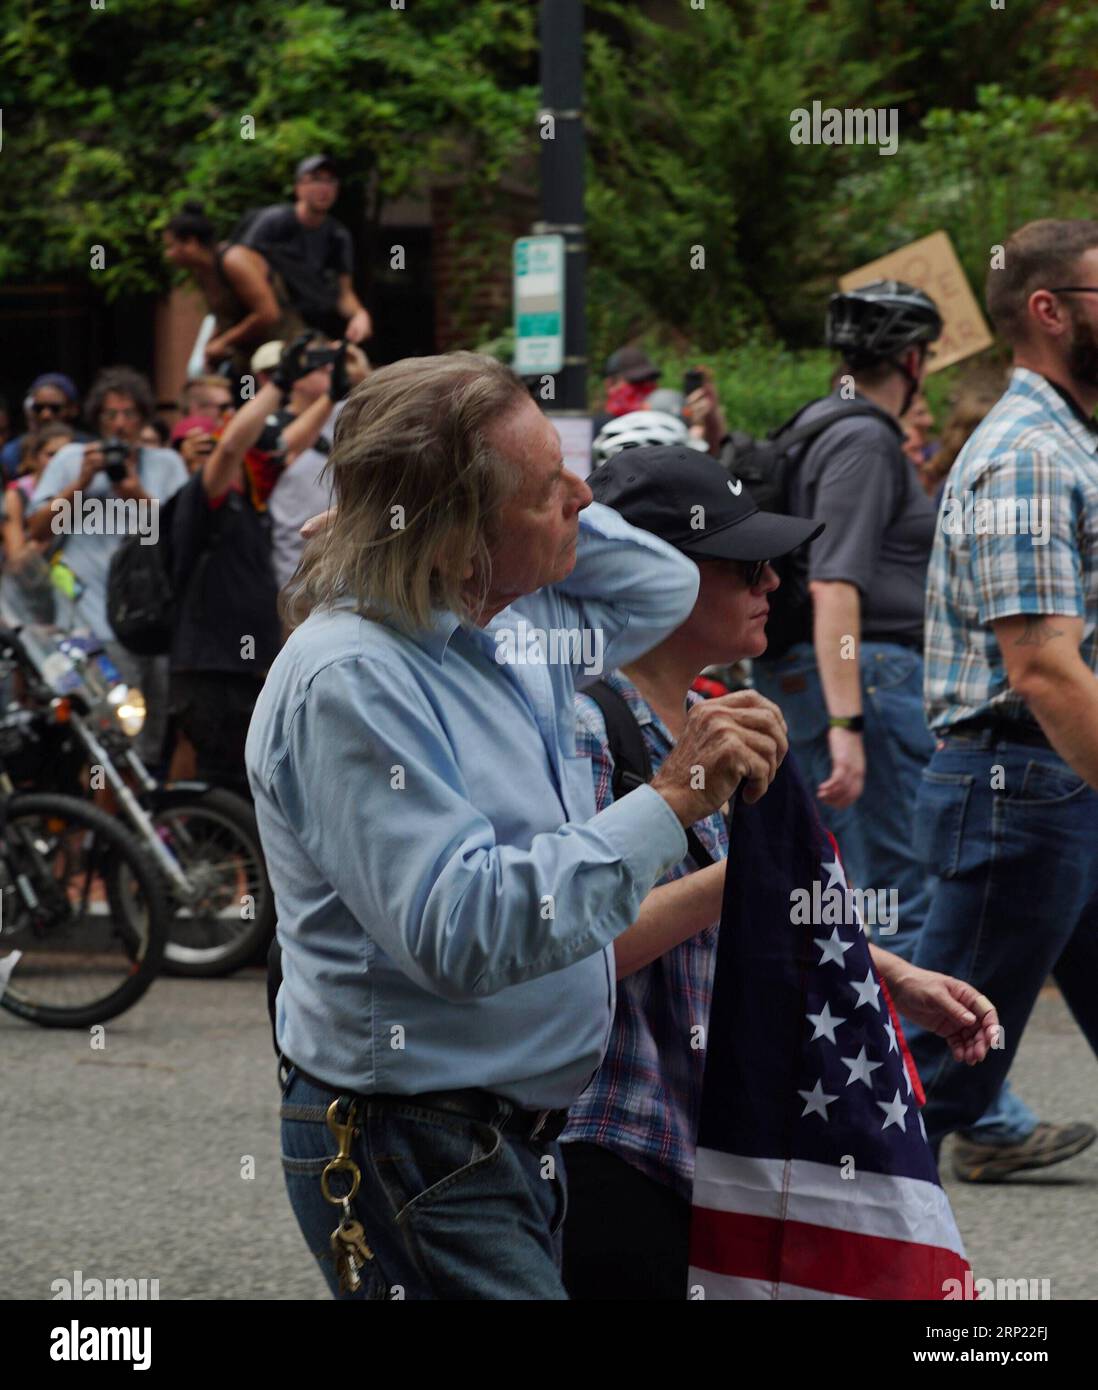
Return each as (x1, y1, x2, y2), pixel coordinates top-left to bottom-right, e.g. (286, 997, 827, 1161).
(0, 792, 167, 1029)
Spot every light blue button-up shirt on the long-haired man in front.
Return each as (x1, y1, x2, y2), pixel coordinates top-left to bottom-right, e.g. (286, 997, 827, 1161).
(247, 503, 698, 1109)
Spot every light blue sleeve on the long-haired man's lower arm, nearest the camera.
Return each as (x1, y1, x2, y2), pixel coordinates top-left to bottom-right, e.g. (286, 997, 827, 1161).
(270, 650, 687, 1001)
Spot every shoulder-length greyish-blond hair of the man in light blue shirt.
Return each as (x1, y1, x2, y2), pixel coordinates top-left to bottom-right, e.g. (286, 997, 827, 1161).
(281, 352, 530, 631)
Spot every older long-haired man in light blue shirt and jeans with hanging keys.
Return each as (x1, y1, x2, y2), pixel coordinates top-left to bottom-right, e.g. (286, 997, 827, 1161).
(247, 353, 787, 1298)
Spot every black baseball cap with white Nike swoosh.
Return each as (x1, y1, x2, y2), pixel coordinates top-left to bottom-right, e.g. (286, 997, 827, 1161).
(587, 445, 823, 560)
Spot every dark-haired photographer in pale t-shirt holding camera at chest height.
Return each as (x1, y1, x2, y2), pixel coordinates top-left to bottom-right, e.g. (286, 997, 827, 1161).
(26, 367, 186, 763)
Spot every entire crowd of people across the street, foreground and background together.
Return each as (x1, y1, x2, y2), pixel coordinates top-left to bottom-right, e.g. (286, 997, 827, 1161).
(0, 201, 1098, 1300)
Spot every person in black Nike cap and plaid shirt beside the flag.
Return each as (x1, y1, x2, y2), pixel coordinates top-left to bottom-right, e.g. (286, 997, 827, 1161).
(560, 445, 1000, 1300)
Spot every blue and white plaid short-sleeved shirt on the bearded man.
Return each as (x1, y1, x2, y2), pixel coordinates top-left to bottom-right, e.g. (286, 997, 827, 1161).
(924, 367, 1098, 733)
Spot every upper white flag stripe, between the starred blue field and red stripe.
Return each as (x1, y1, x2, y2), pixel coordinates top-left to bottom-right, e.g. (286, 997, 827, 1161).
(694, 1148, 965, 1262)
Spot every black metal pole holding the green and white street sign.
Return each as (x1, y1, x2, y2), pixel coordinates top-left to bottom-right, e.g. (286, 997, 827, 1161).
(534, 0, 587, 413)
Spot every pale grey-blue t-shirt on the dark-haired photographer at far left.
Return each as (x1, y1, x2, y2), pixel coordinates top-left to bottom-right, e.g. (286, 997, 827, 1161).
(31, 443, 186, 641)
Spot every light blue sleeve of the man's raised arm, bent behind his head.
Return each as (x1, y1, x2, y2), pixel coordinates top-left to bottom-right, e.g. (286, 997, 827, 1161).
(547, 502, 700, 670)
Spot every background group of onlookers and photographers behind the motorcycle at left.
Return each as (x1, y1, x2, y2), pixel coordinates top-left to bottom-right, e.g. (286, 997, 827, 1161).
(0, 156, 371, 792)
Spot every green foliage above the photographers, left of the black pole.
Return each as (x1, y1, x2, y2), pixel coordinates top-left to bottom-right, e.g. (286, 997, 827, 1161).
(0, 0, 536, 295)
